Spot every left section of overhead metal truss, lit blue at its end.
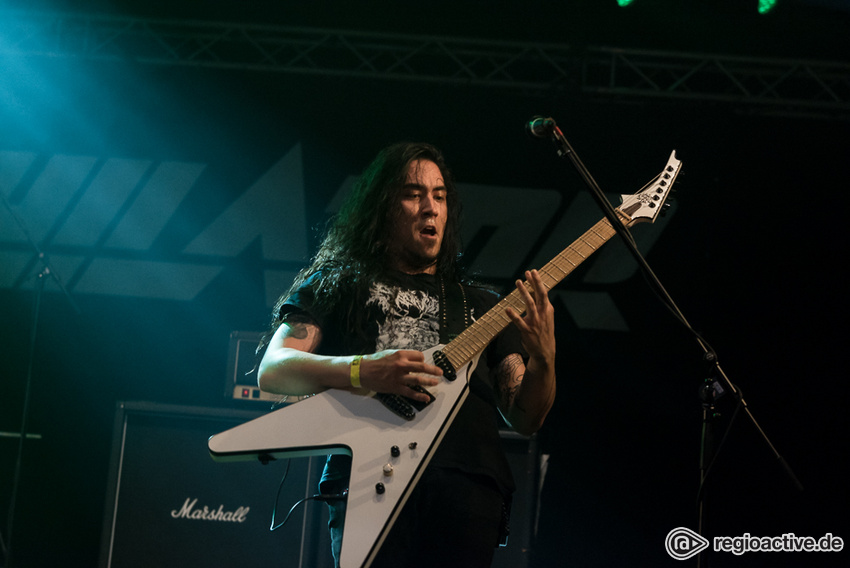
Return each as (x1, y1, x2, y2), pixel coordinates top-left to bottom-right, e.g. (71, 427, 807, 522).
(0, 13, 574, 90)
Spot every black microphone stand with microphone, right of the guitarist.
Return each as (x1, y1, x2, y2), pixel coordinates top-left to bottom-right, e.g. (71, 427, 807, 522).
(526, 117, 803, 567)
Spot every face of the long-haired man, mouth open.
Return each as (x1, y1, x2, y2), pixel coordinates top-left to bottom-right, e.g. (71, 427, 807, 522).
(390, 160, 448, 274)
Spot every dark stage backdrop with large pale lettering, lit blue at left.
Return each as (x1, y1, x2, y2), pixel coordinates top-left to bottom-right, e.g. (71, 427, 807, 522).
(0, 0, 850, 568)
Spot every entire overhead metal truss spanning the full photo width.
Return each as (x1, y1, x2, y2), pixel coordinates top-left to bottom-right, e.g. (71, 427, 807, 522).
(0, 12, 850, 119)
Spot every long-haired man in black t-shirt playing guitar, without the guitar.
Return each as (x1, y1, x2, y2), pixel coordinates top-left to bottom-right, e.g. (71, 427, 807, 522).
(259, 143, 555, 568)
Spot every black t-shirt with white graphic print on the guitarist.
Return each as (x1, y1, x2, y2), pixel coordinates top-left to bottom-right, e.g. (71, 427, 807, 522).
(282, 272, 524, 494)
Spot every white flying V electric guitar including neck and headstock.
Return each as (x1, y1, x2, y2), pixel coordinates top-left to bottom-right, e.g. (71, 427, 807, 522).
(209, 151, 682, 568)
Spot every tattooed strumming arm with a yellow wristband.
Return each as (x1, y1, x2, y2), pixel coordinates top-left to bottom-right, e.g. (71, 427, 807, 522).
(258, 314, 442, 402)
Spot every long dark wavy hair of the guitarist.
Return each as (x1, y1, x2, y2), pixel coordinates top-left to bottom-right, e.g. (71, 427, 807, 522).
(261, 142, 461, 338)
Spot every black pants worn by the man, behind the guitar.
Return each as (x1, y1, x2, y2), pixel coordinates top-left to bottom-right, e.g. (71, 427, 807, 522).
(328, 468, 504, 568)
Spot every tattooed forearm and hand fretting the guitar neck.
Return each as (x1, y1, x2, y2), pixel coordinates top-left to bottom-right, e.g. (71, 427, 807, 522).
(495, 270, 556, 435)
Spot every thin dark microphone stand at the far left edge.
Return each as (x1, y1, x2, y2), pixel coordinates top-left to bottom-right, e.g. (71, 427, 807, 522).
(0, 192, 81, 568)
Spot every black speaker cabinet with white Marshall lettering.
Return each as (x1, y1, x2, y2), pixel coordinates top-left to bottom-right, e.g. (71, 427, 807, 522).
(100, 402, 332, 568)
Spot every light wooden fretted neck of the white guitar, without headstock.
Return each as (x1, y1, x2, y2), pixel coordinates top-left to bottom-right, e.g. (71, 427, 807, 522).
(443, 212, 622, 369)
